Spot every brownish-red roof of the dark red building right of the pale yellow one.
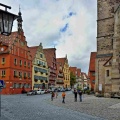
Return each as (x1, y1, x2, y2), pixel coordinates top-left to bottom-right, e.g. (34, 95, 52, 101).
(43, 48, 56, 67)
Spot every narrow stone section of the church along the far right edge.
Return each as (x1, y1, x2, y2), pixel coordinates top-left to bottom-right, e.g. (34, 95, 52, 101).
(111, 2, 120, 92)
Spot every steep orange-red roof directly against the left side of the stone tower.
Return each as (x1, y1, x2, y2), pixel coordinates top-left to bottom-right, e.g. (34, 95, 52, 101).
(89, 52, 97, 71)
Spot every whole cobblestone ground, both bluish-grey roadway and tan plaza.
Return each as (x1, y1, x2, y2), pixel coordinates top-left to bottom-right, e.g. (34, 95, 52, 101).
(0, 91, 120, 120)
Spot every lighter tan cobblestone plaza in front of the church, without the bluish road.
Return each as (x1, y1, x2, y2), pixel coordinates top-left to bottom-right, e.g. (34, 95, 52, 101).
(50, 93, 120, 120)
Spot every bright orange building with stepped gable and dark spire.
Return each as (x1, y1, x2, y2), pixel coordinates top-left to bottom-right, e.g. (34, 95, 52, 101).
(0, 12, 32, 94)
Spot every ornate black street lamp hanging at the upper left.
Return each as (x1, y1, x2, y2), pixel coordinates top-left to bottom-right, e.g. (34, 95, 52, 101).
(0, 3, 17, 35)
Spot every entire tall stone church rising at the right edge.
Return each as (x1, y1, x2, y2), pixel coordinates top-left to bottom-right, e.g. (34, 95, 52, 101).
(95, 0, 120, 97)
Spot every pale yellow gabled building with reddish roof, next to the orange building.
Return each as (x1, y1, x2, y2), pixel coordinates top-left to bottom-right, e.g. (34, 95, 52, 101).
(30, 43, 49, 90)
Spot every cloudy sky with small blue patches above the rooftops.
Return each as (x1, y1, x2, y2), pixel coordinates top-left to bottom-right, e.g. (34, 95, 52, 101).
(0, 0, 97, 73)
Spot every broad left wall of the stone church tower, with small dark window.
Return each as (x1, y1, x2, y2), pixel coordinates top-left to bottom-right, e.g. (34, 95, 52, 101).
(95, 0, 120, 96)
